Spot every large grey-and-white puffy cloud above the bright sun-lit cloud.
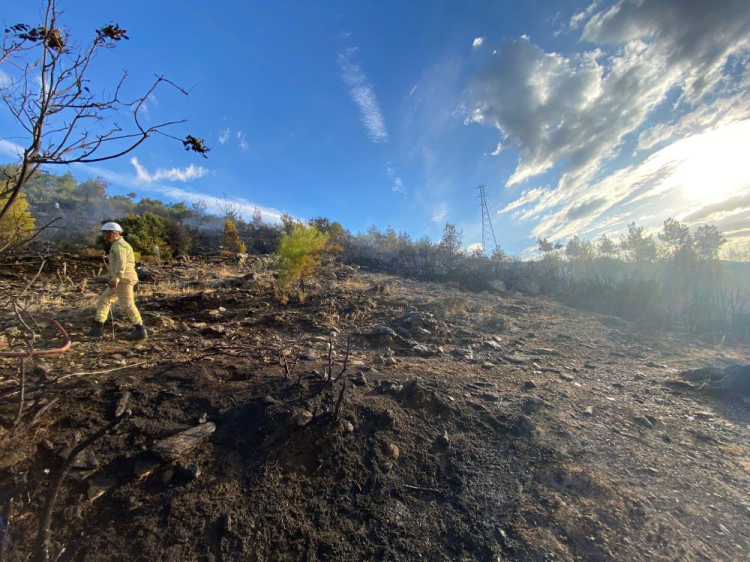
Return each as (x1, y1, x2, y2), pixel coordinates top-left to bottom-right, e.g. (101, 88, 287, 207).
(467, 0, 750, 186)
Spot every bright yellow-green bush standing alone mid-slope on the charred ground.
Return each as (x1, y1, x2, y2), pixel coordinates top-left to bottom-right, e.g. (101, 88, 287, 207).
(275, 224, 333, 303)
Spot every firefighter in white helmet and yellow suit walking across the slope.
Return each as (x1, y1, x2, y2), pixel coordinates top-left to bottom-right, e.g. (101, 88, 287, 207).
(89, 222, 147, 340)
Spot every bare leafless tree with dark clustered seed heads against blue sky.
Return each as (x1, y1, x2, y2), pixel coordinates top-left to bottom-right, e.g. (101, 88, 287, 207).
(0, 0, 209, 225)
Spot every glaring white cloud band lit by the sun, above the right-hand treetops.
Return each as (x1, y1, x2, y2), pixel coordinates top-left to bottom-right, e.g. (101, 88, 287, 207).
(520, 120, 750, 240)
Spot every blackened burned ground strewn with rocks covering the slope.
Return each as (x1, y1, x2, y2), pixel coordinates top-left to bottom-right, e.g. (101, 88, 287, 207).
(0, 258, 750, 561)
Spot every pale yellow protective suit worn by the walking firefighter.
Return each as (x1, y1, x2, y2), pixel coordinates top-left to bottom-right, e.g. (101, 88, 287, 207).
(95, 238, 143, 325)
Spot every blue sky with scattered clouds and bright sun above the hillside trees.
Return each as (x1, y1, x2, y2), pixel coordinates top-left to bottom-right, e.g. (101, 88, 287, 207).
(0, 0, 750, 254)
